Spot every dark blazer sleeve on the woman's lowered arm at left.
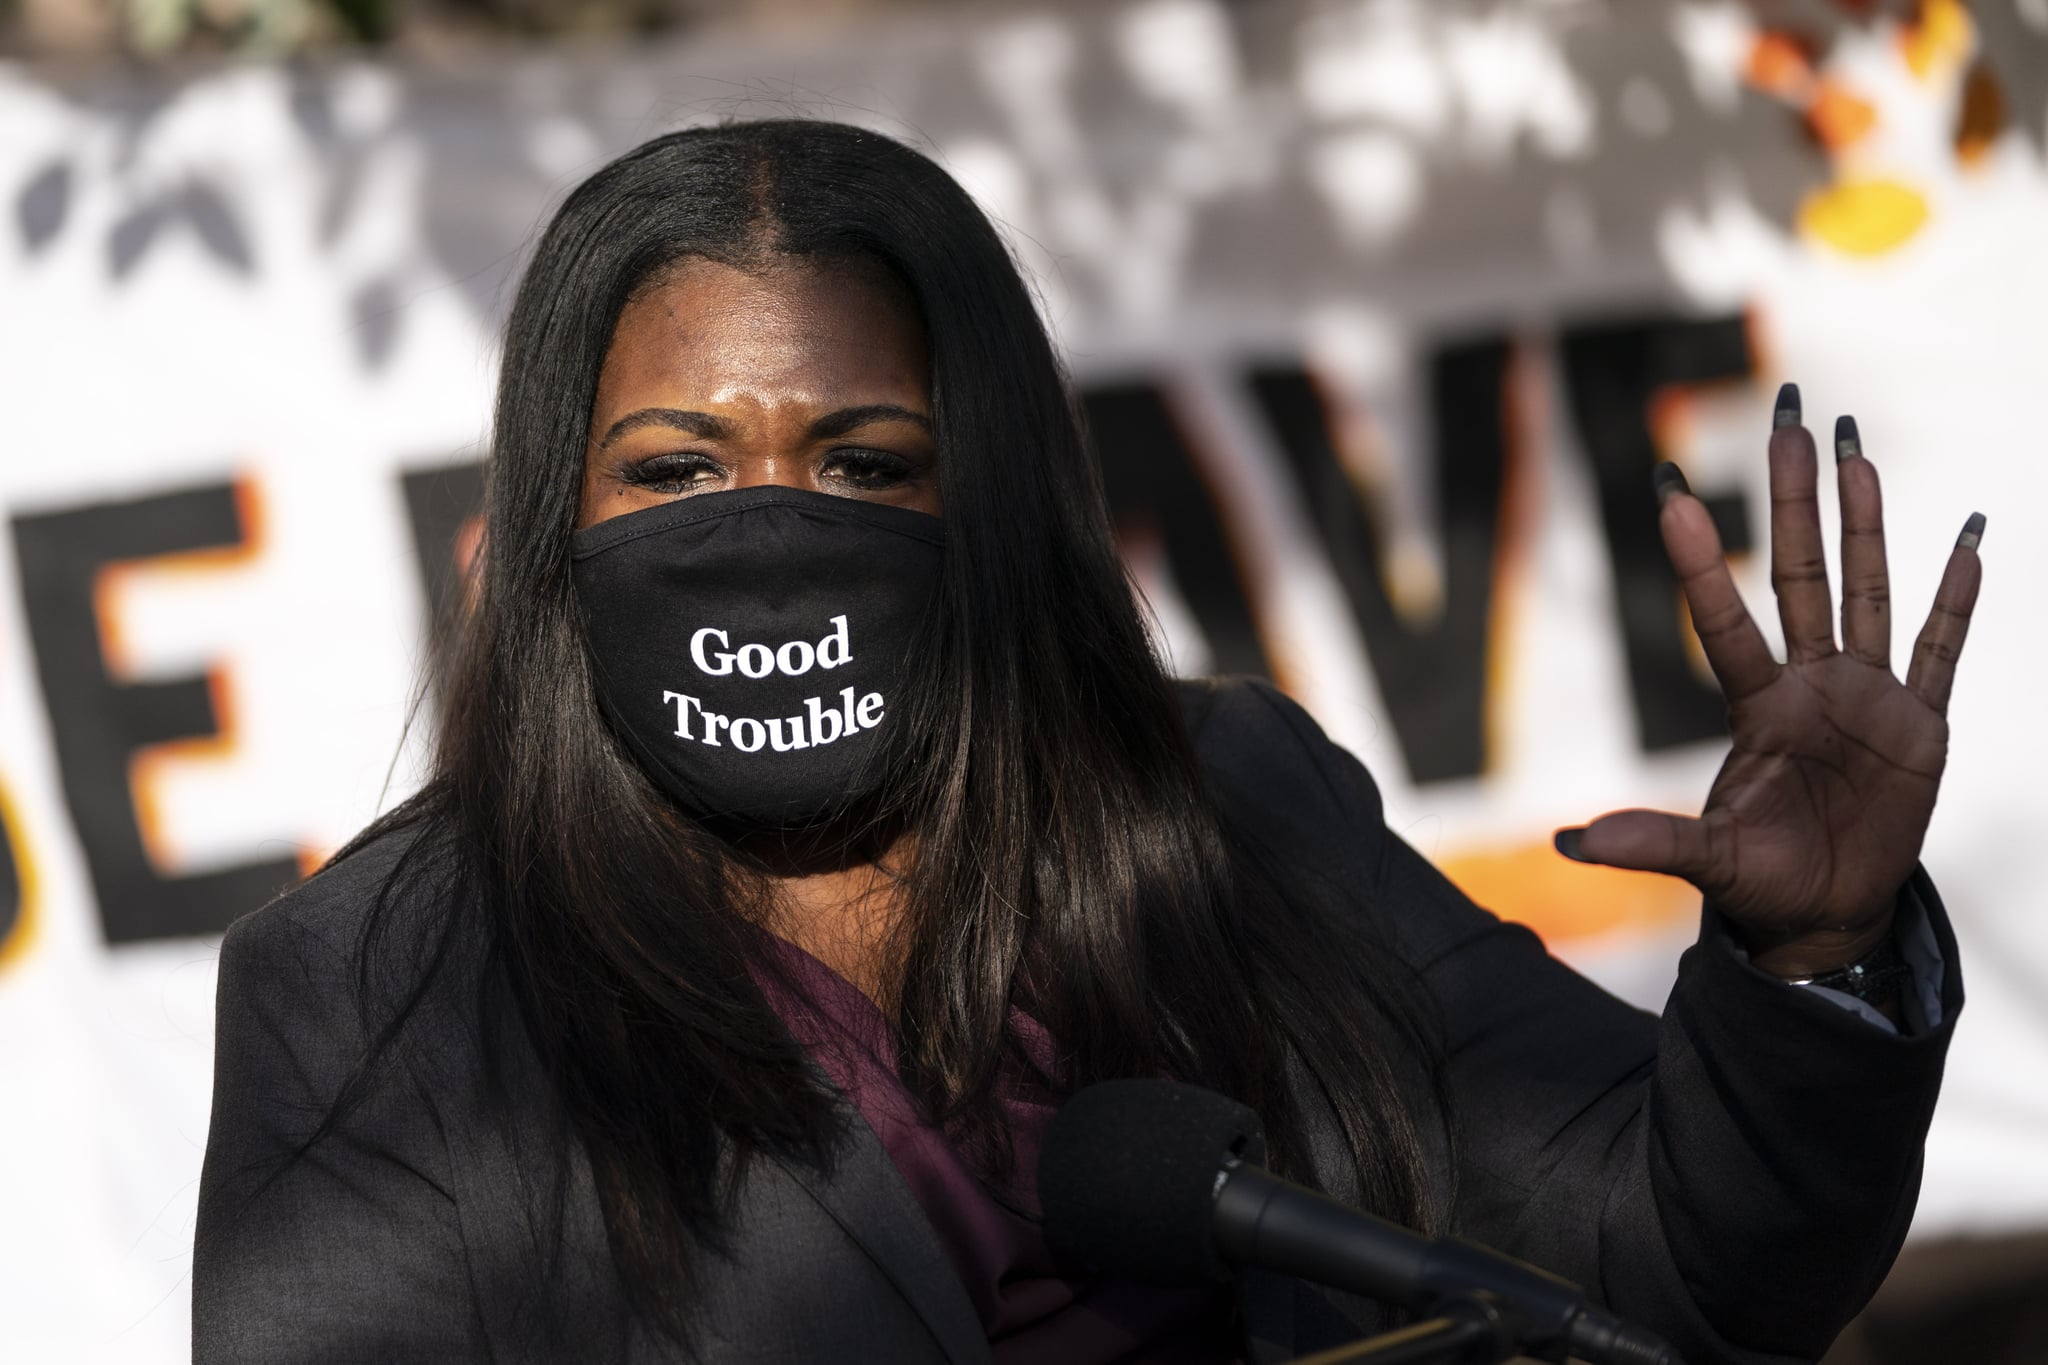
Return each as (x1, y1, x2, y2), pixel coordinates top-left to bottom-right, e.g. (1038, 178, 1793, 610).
(193, 902, 487, 1365)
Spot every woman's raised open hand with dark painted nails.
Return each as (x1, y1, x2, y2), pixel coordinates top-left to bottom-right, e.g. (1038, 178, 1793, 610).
(1556, 385, 1985, 976)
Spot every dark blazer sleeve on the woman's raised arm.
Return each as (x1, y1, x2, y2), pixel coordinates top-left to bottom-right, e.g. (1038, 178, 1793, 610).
(1212, 688, 1962, 1365)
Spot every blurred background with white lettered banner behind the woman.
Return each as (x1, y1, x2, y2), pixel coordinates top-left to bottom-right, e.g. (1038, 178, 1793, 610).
(0, 0, 2048, 1365)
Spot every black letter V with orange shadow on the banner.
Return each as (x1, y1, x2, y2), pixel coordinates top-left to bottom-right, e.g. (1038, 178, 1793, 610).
(1251, 338, 1509, 782)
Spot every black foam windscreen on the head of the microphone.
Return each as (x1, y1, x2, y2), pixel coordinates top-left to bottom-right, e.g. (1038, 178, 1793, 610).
(1038, 1081, 1266, 1285)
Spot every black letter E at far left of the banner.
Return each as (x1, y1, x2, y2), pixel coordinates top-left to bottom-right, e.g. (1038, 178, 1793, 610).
(14, 483, 299, 943)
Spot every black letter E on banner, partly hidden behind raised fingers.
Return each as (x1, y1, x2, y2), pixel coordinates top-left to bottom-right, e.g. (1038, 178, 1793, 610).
(1559, 317, 1763, 749)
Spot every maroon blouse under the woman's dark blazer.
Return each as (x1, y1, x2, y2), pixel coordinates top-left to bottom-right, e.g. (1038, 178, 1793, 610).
(760, 939, 1239, 1365)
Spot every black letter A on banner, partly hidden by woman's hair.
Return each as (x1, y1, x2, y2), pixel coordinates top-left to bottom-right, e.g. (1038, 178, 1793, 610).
(1081, 383, 1272, 677)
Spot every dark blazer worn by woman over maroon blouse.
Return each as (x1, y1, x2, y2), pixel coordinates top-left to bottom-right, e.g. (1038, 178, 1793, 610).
(193, 684, 1962, 1365)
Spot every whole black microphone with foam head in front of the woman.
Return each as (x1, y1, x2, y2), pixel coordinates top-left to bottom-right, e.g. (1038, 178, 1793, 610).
(1038, 1081, 1679, 1365)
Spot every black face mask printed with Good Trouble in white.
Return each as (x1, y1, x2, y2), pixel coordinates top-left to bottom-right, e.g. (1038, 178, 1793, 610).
(569, 487, 944, 829)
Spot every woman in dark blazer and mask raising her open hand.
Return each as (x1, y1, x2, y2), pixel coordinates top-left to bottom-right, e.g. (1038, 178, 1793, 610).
(195, 121, 1980, 1363)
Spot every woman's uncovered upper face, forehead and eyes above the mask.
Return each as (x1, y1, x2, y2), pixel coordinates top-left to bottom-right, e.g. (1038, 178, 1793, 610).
(578, 258, 940, 526)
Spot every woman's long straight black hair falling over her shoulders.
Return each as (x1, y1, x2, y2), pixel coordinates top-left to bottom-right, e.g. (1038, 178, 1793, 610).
(344, 121, 1440, 1326)
